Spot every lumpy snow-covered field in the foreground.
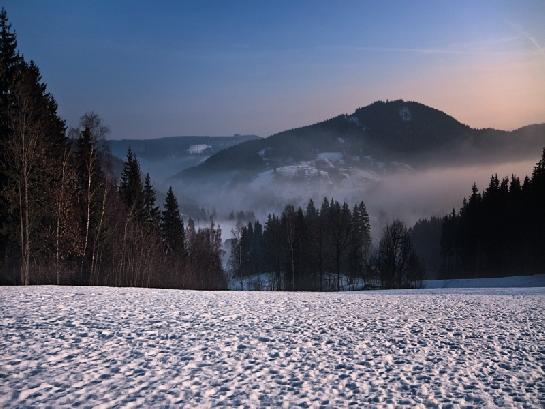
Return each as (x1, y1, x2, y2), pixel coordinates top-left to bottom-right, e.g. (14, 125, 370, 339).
(0, 287, 545, 407)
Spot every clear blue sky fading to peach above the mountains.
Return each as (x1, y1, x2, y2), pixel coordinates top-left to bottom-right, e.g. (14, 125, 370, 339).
(0, 0, 545, 139)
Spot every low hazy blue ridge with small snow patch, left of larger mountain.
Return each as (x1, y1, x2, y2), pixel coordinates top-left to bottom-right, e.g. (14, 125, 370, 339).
(108, 135, 257, 183)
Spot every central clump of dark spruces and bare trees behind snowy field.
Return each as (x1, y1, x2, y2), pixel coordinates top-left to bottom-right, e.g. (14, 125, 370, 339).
(229, 198, 422, 291)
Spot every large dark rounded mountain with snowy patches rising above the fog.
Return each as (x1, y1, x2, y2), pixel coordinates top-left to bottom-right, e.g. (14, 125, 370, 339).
(178, 100, 545, 182)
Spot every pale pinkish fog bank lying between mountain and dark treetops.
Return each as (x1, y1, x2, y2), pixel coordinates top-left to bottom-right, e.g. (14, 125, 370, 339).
(175, 156, 536, 239)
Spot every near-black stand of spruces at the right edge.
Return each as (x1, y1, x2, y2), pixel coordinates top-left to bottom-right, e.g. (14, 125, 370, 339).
(440, 149, 545, 277)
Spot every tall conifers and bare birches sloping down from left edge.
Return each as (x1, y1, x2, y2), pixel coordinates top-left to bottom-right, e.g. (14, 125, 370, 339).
(0, 9, 226, 289)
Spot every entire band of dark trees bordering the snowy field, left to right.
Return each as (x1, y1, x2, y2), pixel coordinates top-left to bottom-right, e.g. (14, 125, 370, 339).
(0, 9, 545, 291)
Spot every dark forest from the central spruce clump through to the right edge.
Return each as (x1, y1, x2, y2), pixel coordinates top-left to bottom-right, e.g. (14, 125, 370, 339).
(229, 149, 545, 291)
